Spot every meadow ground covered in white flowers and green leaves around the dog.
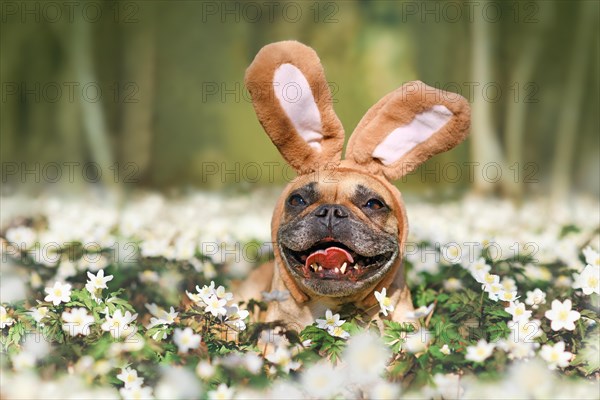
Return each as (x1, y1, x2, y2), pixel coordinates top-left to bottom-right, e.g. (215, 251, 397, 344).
(0, 191, 600, 399)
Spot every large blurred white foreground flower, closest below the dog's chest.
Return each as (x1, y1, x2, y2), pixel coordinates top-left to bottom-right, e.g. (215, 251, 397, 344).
(342, 331, 391, 385)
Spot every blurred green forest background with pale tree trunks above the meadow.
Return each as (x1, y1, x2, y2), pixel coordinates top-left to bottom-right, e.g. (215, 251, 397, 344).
(0, 0, 600, 199)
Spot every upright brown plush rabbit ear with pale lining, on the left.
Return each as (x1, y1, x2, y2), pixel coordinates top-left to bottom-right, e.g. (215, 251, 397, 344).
(245, 41, 344, 174)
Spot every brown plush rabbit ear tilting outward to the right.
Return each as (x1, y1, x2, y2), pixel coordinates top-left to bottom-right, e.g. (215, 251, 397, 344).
(346, 81, 470, 180)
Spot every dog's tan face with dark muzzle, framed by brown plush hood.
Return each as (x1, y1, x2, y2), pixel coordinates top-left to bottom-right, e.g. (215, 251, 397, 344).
(276, 172, 401, 297)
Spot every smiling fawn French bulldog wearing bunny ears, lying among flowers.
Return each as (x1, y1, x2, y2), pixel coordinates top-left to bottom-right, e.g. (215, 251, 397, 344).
(238, 41, 470, 329)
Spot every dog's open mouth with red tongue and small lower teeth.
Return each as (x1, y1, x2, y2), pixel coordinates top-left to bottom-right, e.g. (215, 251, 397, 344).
(283, 240, 395, 282)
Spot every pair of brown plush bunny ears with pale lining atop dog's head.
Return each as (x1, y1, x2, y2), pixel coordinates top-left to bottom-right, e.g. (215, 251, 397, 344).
(245, 41, 470, 181)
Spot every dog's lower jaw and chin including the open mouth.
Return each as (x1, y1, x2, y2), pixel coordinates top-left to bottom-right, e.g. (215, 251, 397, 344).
(278, 242, 399, 297)
